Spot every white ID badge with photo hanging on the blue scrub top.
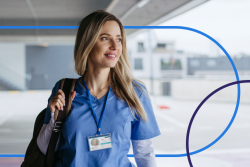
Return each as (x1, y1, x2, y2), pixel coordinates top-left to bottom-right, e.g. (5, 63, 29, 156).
(87, 133, 112, 151)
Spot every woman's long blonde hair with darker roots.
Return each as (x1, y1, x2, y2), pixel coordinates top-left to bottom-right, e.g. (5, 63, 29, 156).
(74, 10, 149, 122)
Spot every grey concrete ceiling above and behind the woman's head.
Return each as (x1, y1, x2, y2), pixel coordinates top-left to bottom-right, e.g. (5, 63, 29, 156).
(0, 0, 208, 42)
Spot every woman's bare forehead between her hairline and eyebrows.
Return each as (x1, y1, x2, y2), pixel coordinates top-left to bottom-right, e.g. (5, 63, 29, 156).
(100, 21, 121, 35)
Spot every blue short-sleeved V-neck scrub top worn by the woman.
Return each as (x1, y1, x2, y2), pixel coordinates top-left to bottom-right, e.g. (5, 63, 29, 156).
(44, 79, 161, 167)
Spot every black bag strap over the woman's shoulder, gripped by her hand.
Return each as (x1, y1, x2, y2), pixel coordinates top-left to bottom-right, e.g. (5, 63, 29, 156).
(45, 78, 76, 167)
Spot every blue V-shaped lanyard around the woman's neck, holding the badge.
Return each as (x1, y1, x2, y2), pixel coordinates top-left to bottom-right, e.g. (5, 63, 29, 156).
(82, 77, 111, 135)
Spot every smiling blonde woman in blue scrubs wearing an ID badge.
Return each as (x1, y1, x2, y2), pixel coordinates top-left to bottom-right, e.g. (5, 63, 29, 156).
(37, 11, 160, 167)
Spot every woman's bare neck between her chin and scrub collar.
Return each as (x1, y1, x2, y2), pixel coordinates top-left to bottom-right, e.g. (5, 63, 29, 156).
(84, 68, 110, 93)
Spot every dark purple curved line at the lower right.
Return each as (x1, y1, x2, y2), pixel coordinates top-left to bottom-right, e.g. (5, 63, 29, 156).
(186, 80, 250, 167)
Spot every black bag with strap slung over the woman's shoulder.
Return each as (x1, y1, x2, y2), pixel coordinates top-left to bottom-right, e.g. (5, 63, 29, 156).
(21, 78, 76, 167)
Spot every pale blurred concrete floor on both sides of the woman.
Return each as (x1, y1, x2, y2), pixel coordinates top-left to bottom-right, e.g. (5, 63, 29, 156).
(0, 91, 250, 167)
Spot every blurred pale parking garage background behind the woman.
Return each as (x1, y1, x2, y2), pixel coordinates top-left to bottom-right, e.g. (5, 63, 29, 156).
(0, 0, 250, 167)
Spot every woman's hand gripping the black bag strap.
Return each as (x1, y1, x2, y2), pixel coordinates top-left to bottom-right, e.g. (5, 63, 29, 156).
(49, 89, 76, 120)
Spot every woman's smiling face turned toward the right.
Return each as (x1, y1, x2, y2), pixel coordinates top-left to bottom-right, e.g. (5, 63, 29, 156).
(88, 21, 122, 68)
